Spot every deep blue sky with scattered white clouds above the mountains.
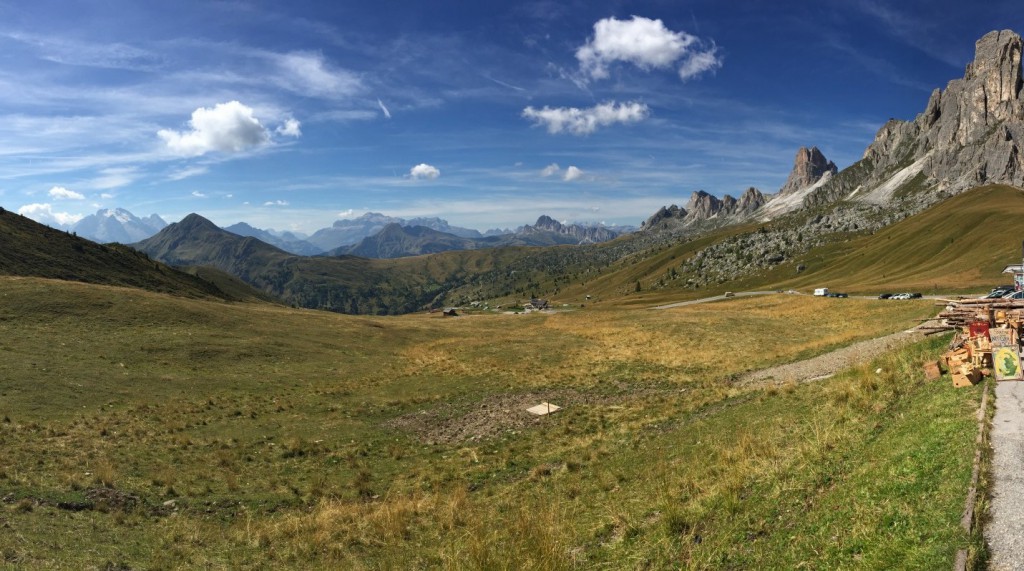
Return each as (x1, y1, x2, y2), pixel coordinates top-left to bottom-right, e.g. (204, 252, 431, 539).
(0, 0, 1024, 232)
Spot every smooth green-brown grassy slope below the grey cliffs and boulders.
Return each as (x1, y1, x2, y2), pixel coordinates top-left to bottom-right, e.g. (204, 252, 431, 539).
(563, 185, 1024, 306)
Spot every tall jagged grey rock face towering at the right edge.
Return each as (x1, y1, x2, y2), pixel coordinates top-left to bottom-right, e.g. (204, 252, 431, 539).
(805, 30, 1024, 210)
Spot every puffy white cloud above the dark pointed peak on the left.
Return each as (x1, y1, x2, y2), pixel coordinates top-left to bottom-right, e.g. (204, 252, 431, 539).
(157, 101, 270, 157)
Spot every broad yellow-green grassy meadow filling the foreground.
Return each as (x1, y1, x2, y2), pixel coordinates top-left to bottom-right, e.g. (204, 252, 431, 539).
(0, 277, 983, 569)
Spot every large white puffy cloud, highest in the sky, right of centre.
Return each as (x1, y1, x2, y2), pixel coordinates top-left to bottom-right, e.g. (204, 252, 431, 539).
(575, 16, 722, 80)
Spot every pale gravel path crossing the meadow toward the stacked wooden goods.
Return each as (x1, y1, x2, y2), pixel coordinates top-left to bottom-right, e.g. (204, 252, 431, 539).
(739, 330, 924, 385)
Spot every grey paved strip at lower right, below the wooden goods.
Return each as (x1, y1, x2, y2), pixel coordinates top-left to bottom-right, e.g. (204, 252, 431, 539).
(985, 382, 1024, 571)
